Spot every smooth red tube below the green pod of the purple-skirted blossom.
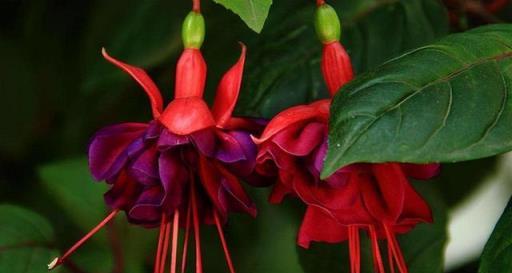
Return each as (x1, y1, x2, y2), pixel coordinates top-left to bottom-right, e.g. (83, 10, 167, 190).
(174, 48, 206, 99)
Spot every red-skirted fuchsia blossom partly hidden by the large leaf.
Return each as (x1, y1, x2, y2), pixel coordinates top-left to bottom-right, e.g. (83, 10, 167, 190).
(255, 1, 439, 273)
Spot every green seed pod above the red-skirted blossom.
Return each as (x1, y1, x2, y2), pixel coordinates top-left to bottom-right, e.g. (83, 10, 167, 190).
(315, 4, 341, 44)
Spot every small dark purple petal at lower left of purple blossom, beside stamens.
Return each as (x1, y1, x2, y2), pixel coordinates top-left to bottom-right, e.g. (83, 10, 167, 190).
(128, 186, 164, 223)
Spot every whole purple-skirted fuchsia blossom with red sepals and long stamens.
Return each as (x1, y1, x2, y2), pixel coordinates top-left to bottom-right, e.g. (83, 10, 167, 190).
(48, 1, 262, 273)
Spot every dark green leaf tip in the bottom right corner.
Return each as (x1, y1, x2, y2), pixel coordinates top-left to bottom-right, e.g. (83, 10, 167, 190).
(478, 194, 512, 273)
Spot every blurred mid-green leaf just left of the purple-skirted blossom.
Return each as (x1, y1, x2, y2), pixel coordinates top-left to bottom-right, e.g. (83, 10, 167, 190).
(39, 158, 107, 231)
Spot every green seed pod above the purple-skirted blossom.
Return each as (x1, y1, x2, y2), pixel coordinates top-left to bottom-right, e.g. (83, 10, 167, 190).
(181, 11, 205, 49)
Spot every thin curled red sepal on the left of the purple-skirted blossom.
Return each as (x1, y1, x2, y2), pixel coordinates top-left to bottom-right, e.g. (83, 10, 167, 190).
(102, 48, 163, 119)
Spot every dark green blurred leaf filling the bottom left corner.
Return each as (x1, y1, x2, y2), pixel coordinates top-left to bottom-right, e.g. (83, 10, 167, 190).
(0, 205, 57, 273)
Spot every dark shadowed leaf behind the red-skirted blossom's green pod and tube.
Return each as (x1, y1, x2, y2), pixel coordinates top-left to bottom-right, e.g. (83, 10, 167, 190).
(237, 0, 448, 117)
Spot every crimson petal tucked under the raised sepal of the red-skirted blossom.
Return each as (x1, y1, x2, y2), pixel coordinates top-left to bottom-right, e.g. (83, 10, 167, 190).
(272, 122, 327, 156)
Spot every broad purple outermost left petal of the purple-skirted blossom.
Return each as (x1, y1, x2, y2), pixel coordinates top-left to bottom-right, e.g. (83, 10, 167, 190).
(89, 123, 147, 180)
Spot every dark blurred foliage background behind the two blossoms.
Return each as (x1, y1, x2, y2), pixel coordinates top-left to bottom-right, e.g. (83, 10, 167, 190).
(0, 0, 512, 273)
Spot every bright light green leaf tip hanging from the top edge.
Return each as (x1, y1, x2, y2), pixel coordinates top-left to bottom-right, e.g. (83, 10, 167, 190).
(214, 0, 272, 33)
